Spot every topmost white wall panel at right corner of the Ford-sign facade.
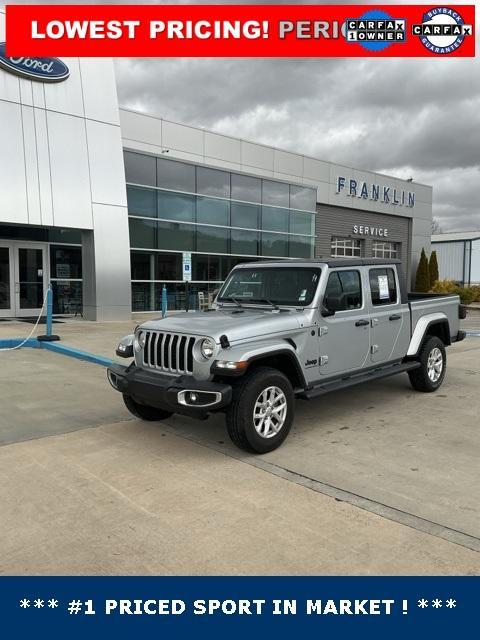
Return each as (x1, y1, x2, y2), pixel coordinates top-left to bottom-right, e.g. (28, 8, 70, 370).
(80, 58, 120, 125)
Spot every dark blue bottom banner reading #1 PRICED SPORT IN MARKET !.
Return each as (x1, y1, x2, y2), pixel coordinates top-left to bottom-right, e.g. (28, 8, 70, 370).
(0, 577, 480, 640)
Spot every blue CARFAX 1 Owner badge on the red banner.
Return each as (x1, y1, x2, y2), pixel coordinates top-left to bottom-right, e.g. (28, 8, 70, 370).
(344, 9, 406, 51)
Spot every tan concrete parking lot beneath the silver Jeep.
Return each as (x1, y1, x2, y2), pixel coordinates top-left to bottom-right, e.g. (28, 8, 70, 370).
(0, 318, 480, 575)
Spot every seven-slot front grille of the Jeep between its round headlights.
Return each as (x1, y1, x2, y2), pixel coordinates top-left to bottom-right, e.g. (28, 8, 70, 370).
(143, 331, 195, 374)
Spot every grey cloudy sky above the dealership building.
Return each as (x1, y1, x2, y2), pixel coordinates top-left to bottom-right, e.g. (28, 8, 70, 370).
(11, 0, 480, 231)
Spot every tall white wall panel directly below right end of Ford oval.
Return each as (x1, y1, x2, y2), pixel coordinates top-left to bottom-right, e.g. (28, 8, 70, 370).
(47, 112, 92, 229)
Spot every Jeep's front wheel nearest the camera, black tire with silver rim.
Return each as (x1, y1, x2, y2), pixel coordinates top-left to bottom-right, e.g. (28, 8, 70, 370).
(227, 367, 295, 453)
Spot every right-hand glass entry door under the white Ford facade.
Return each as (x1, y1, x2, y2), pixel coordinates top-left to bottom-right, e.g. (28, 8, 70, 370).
(15, 243, 47, 317)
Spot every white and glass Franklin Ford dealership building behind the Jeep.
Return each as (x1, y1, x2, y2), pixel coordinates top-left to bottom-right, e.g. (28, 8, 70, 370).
(0, 30, 432, 320)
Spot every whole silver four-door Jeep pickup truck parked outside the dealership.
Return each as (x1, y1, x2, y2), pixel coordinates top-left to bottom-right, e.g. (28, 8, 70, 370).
(108, 258, 465, 453)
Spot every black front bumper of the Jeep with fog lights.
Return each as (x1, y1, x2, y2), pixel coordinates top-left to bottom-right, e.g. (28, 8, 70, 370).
(107, 364, 232, 418)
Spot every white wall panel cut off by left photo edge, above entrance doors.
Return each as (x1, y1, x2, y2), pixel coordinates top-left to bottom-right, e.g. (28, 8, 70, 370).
(0, 100, 28, 224)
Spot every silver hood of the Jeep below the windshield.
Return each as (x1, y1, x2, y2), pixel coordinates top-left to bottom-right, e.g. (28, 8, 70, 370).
(141, 307, 306, 342)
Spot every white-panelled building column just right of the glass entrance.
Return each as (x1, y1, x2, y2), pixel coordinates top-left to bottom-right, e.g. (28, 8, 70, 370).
(82, 204, 132, 321)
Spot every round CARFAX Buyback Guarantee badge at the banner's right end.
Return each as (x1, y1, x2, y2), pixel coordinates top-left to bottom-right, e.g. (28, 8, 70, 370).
(412, 7, 473, 55)
